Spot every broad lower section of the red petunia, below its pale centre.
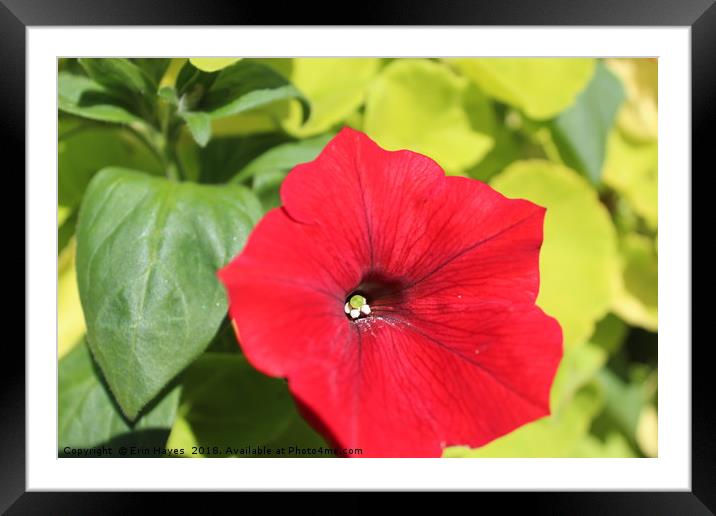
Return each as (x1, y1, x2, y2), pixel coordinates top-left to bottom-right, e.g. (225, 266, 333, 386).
(289, 306, 562, 457)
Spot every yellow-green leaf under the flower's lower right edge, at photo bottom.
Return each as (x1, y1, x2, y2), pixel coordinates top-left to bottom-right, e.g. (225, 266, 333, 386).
(443, 387, 602, 458)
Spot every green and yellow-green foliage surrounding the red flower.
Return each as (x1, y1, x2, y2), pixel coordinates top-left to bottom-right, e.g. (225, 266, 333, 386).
(58, 58, 658, 457)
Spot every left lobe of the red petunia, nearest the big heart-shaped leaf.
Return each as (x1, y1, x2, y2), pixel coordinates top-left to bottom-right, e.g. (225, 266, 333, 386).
(219, 209, 360, 377)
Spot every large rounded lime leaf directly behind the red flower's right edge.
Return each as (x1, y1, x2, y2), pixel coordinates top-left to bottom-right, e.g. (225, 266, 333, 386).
(491, 160, 619, 346)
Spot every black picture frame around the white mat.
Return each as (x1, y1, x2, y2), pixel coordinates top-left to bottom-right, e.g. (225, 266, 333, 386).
(0, 0, 716, 515)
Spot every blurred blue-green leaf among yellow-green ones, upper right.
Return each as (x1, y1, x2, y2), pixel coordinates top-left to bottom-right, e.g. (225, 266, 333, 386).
(551, 62, 624, 184)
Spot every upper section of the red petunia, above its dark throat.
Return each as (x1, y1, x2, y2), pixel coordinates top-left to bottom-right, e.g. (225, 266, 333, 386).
(281, 128, 544, 302)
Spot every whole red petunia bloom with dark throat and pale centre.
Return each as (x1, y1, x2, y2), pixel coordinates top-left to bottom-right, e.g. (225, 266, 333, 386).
(220, 129, 562, 457)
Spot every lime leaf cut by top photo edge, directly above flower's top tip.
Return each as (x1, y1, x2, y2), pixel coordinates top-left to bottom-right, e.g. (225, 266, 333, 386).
(282, 57, 380, 138)
